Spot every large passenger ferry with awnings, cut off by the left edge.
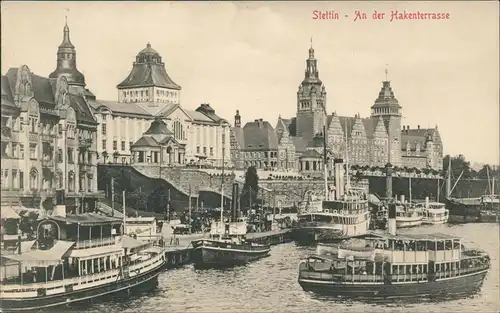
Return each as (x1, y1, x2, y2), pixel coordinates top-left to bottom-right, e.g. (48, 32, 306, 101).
(0, 191, 165, 312)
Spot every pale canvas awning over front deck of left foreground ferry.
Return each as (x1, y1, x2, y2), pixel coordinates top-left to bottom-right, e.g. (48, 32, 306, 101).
(3, 240, 75, 267)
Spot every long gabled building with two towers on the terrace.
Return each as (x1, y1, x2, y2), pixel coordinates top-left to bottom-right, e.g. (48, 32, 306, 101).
(231, 47, 443, 173)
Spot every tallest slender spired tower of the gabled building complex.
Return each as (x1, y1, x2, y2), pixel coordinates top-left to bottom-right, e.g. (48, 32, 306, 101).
(296, 43, 326, 141)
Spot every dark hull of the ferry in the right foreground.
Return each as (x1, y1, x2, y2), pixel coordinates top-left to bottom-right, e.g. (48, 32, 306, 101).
(299, 270, 488, 299)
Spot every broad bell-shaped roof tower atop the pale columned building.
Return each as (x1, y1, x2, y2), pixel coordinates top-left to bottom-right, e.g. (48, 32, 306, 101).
(116, 43, 181, 115)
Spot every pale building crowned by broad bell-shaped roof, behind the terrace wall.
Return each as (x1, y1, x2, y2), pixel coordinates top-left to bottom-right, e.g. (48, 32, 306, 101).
(90, 43, 231, 166)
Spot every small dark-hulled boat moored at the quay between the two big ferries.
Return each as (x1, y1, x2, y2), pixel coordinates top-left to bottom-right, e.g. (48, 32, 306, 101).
(191, 221, 271, 268)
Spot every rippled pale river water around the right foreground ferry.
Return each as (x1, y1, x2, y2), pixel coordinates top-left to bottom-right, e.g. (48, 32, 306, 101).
(81, 224, 500, 313)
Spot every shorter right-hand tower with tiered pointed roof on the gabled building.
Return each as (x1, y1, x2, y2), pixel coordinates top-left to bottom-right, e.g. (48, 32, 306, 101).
(371, 70, 402, 166)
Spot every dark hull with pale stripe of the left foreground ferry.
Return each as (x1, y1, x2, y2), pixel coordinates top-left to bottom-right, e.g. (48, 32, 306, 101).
(0, 266, 163, 312)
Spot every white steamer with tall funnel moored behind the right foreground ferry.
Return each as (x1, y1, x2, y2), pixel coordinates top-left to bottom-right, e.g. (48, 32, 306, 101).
(295, 159, 370, 244)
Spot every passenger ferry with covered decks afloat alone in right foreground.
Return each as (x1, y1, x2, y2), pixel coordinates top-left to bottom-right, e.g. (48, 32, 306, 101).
(298, 205, 490, 298)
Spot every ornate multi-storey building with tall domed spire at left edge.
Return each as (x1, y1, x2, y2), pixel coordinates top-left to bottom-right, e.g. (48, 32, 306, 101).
(1, 24, 100, 212)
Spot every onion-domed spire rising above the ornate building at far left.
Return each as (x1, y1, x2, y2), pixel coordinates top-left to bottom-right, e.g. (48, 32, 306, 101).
(49, 21, 85, 94)
